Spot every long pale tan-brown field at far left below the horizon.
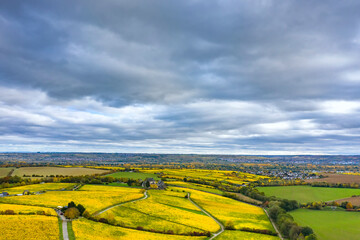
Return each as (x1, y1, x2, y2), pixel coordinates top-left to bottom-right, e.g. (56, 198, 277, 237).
(12, 167, 108, 177)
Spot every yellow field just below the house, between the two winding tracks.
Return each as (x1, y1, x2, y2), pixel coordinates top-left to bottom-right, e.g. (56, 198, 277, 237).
(99, 190, 219, 234)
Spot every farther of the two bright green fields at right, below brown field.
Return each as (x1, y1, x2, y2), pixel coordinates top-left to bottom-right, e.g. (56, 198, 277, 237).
(258, 186, 360, 203)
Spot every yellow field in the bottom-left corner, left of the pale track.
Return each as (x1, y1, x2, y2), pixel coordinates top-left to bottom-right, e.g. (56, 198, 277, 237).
(0, 215, 59, 240)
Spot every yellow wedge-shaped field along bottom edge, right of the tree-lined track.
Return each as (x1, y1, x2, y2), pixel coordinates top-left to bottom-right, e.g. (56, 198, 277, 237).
(72, 218, 206, 240)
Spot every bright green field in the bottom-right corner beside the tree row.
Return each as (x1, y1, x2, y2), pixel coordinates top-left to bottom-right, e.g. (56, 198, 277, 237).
(290, 209, 360, 240)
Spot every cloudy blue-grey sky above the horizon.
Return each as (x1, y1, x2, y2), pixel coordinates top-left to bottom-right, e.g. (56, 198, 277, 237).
(0, 0, 360, 154)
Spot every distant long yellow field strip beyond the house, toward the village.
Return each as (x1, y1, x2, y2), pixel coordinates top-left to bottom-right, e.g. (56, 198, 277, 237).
(142, 169, 269, 185)
